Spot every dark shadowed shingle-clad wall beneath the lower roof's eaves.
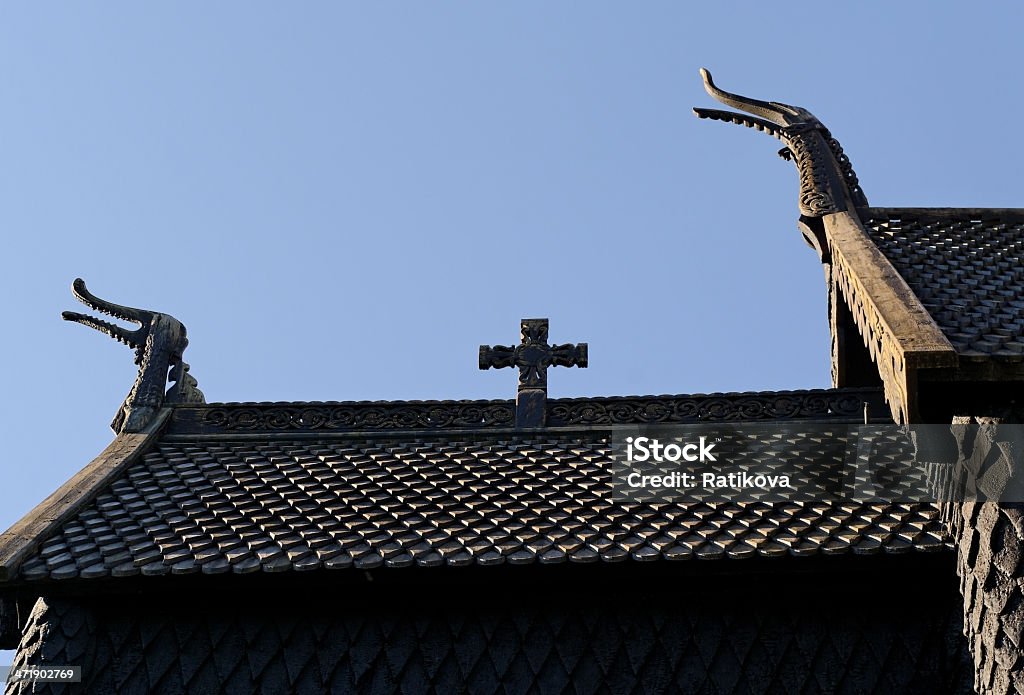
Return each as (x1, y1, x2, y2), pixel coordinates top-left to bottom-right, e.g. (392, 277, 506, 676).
(8, 568, 971, 695)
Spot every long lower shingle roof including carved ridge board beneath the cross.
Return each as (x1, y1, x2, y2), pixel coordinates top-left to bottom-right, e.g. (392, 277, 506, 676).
(0, 389, 947, 584)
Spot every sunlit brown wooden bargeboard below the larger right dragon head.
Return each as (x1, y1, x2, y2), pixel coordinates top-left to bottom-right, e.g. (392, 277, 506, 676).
(823, 212, 957, 423)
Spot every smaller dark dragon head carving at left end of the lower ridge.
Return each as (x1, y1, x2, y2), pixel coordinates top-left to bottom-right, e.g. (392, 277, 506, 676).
(60, 278, 205, 433)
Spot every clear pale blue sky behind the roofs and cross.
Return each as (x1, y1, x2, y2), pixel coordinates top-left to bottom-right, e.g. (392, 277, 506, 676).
(0, 2, 1024, 662)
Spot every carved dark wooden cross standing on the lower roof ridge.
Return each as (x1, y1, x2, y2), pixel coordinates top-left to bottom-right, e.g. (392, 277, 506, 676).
(480, 318, 587, 427)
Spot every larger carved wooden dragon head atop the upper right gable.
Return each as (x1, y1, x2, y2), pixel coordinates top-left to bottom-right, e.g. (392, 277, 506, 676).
(693, 68, 867, 217)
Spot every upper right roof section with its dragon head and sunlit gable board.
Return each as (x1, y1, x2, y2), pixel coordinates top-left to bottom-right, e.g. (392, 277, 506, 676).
(694, 71, 1024, 423)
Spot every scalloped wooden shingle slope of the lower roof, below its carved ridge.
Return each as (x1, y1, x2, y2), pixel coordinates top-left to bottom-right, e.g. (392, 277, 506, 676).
(7, 390, 948, 584)
